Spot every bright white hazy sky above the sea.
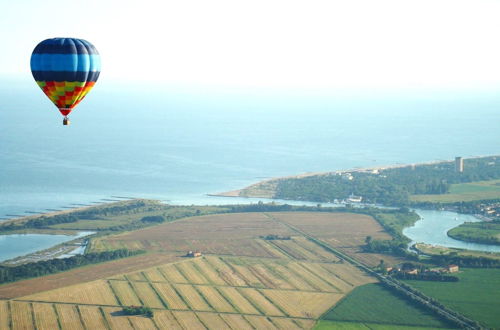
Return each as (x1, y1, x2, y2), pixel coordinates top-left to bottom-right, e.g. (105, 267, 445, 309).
(0, 0, 500, 88)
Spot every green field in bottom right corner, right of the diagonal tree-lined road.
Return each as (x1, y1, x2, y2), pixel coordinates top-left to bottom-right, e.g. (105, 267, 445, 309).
(405, 268, 500, 329)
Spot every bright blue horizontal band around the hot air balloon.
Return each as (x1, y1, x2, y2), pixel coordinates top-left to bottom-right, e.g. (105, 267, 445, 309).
(31, 54, 101, 71)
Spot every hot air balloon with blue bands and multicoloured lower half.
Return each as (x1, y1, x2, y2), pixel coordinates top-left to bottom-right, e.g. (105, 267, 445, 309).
(31, 38, 101, 125)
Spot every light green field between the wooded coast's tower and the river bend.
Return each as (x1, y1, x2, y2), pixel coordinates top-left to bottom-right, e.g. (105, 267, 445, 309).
(410, 180, 500, 203)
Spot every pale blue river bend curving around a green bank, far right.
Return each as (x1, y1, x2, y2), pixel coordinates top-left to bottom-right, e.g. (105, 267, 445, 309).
(403, 209, 500, 252)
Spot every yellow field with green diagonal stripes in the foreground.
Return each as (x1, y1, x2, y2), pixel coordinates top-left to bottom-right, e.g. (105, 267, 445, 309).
(0, 256, 374, 329)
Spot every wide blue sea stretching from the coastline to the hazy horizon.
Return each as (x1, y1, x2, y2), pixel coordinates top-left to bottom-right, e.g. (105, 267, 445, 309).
(0, 78, 500, 217)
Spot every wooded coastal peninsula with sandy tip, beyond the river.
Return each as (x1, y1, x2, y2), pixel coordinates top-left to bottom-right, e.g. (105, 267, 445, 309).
(213, 155, 500, 206)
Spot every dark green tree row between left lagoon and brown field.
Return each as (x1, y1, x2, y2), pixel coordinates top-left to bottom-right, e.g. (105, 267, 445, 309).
(0, 249, 144, 283)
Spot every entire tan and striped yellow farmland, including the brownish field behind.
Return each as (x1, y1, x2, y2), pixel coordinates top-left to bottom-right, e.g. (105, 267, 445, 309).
(0, 212, 458, 329)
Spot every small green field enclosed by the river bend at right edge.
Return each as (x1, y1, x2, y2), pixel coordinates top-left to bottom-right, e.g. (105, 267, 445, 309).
(448, 221, 500, 245)
